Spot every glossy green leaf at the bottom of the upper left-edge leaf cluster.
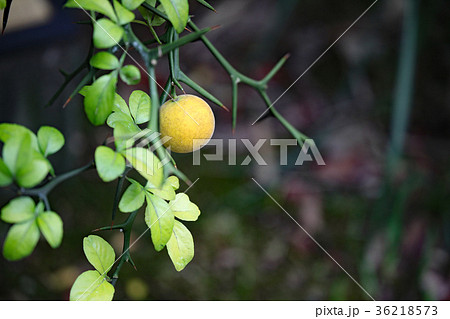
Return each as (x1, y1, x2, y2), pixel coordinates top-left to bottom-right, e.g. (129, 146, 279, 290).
(16, 150, 51, 188)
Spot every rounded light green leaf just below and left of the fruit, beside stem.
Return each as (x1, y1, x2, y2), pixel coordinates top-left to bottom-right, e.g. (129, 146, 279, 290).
(95, 146, 125, 182)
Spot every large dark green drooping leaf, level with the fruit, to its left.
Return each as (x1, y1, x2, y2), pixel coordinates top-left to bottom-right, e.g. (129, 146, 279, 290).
(84, 72, 117, 125)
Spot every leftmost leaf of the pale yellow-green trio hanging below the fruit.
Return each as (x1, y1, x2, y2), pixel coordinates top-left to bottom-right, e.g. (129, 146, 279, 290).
(145, 194, 175, 251)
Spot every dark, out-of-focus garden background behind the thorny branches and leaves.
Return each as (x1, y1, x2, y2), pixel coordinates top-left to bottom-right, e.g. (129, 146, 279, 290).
(0, 0, 450, 300)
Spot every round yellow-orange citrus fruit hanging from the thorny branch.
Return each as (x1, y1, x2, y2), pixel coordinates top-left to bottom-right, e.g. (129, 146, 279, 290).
(159, 94, 215, 153)
